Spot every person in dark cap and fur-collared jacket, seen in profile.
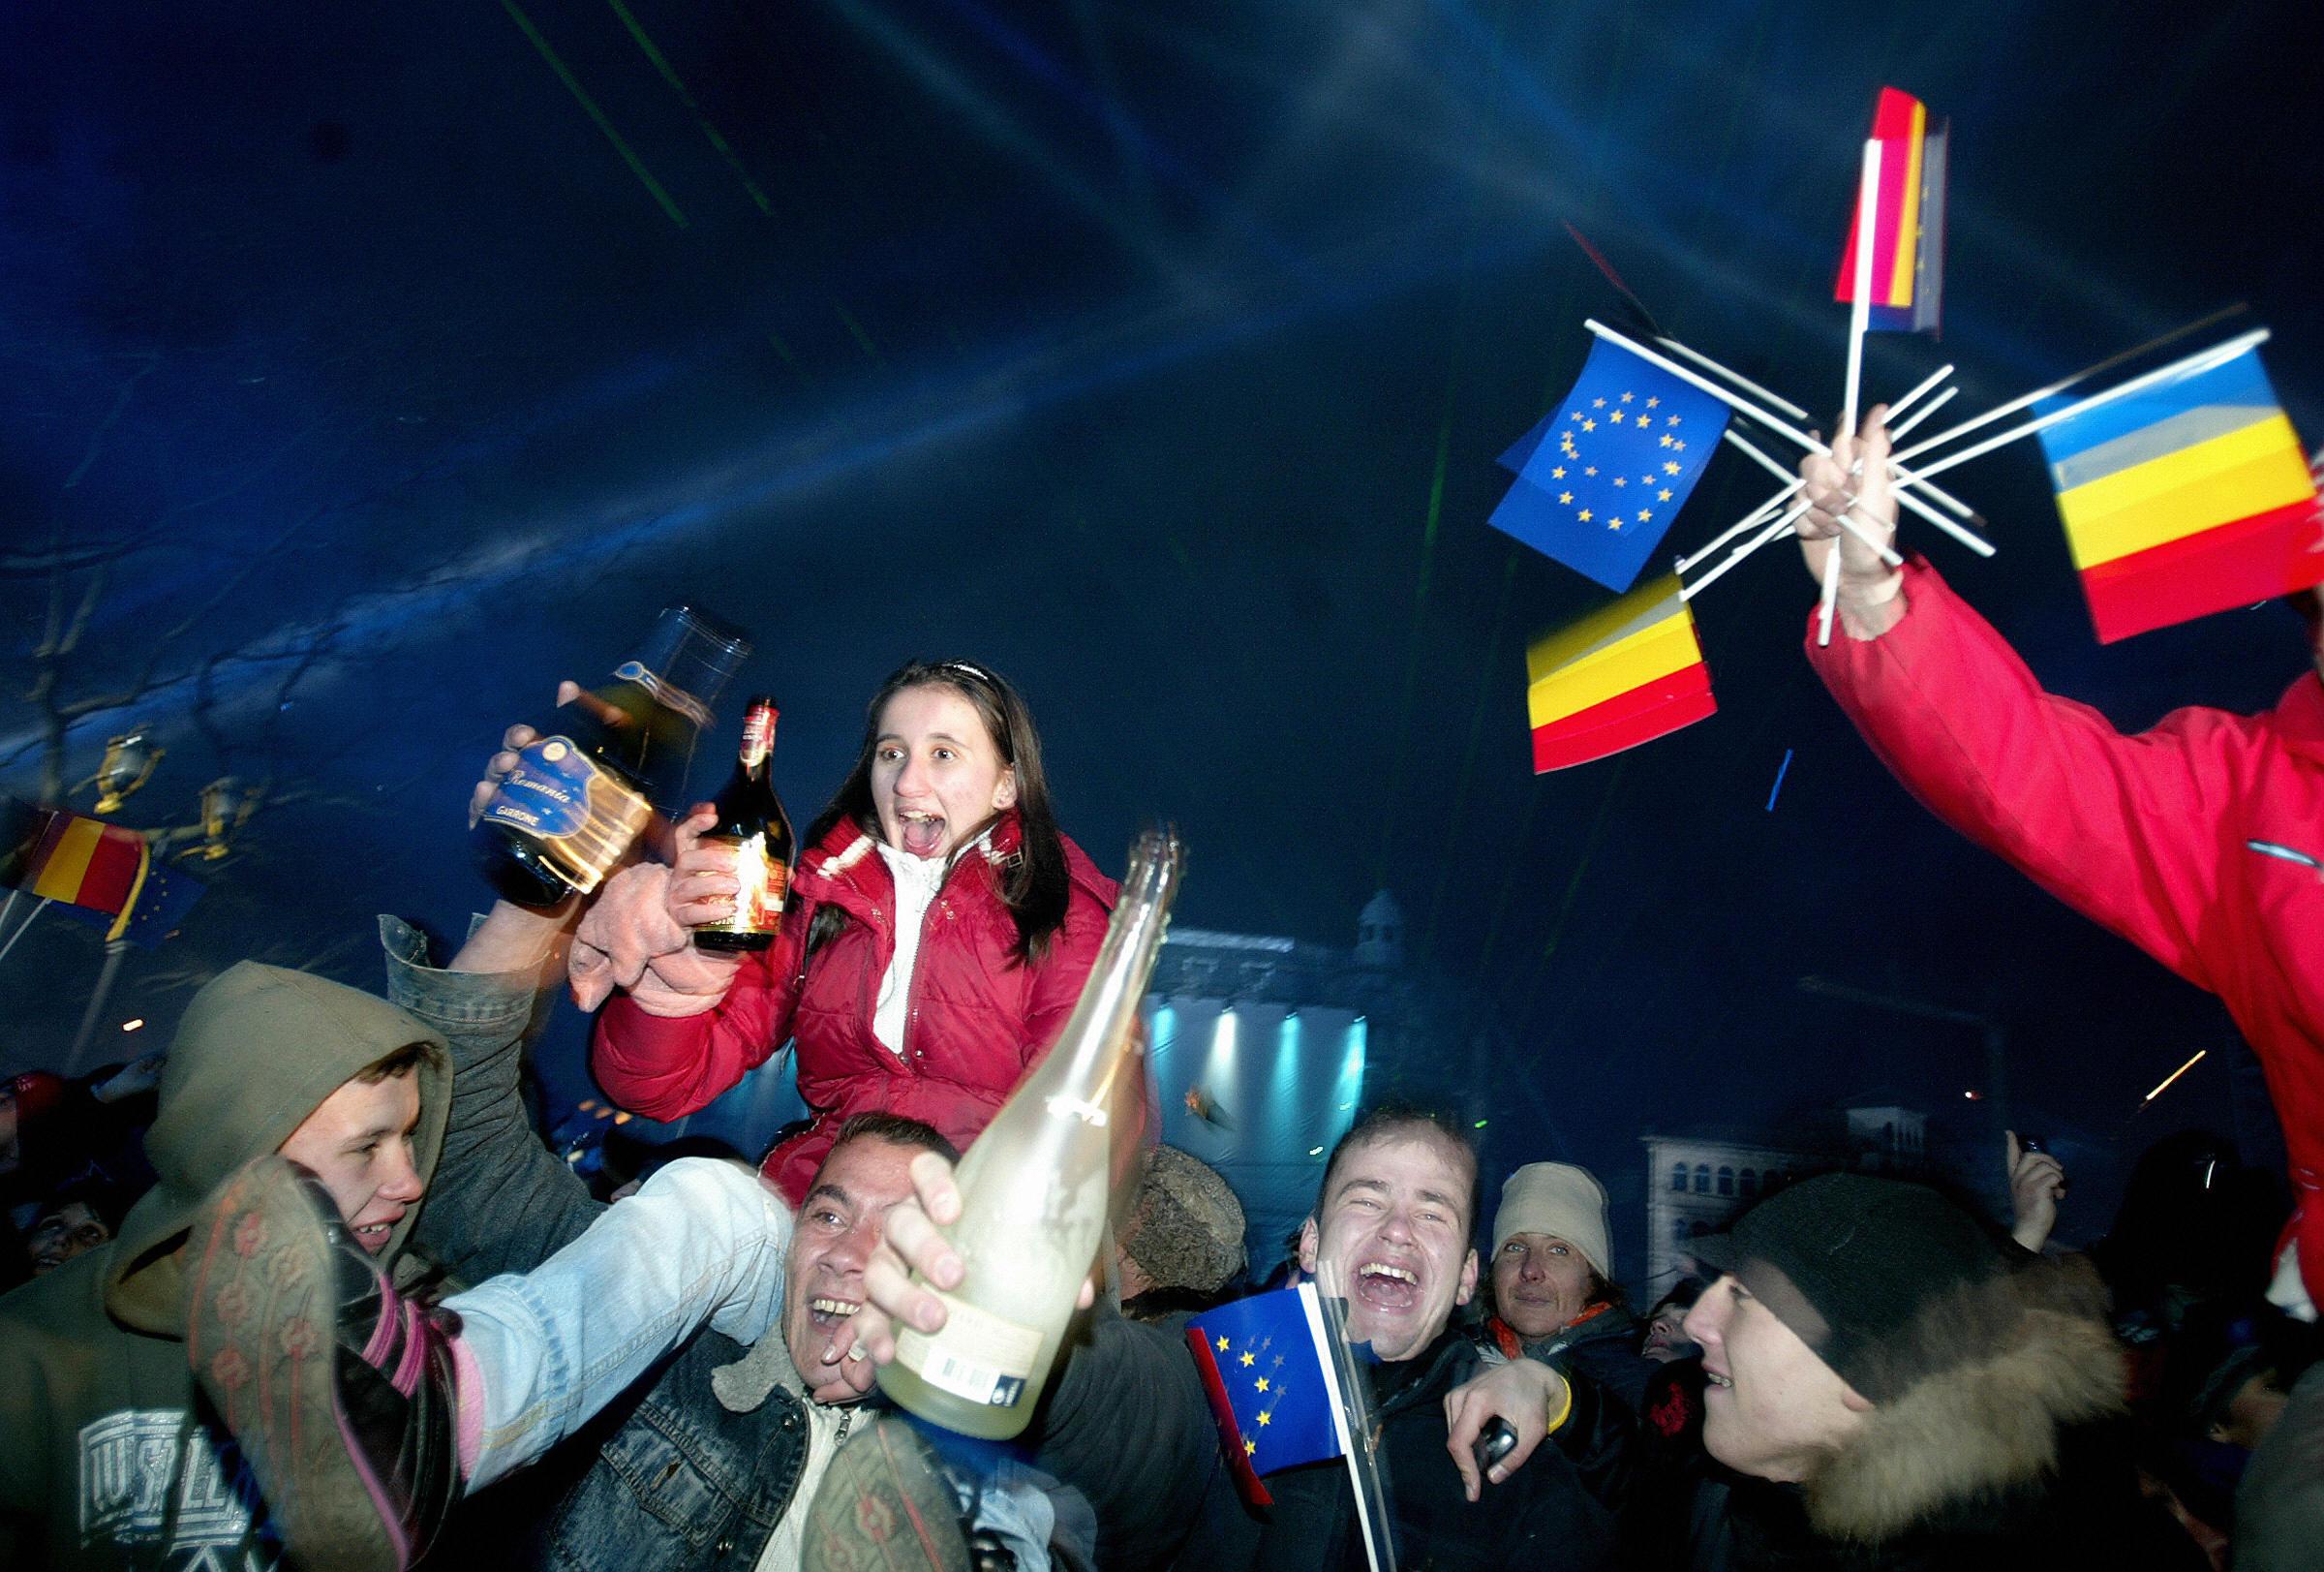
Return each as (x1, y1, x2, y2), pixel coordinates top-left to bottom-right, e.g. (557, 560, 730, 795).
(1638, 1174, 2206, 1572)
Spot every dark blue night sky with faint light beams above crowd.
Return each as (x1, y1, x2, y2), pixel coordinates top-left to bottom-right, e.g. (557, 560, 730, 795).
(0, 0, 2324, 1232)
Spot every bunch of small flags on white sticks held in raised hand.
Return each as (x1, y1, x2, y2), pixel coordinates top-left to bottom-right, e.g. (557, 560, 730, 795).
(1492, 88, 2324, 772)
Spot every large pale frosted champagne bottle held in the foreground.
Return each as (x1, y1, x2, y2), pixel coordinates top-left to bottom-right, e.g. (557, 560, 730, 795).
(878, 830, 1185, 1439)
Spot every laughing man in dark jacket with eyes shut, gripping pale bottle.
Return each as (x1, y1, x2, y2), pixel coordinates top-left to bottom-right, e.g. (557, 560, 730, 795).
(845, 1109, 1620, 1572)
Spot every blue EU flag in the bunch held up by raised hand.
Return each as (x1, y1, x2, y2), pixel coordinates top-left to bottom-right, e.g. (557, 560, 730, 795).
(1492, 340, 1727, 591)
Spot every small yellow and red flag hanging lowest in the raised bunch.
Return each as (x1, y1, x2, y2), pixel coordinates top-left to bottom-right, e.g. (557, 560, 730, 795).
(1524, 574, 1718, 774)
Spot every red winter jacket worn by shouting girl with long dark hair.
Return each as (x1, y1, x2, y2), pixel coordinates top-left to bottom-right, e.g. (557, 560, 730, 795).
(591, 812, 1114, 1205)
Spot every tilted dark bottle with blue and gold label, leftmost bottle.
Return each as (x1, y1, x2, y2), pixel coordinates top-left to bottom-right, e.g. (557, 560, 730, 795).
(470, 607, 750, 907)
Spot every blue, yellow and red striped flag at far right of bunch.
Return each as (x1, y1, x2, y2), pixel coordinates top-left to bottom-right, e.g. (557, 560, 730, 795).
(2040, 349, 2324, 644)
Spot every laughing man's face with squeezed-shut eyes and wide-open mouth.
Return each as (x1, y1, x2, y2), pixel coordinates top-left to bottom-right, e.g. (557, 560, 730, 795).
(1300, 1124, 1476, 1363)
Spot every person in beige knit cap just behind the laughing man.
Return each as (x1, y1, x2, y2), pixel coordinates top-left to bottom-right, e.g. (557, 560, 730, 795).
(1483, 1162, 1655, 1414)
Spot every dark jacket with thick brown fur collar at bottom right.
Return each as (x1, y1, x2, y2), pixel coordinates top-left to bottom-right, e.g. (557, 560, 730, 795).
(1634, 1260, 2206, 1572)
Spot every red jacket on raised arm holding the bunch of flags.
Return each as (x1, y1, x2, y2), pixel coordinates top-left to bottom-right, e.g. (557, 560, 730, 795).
(1808, 563, 2324, 1305)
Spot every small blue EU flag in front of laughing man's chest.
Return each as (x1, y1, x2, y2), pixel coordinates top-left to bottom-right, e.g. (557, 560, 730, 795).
(1185, 1283, 1348, 1507)
